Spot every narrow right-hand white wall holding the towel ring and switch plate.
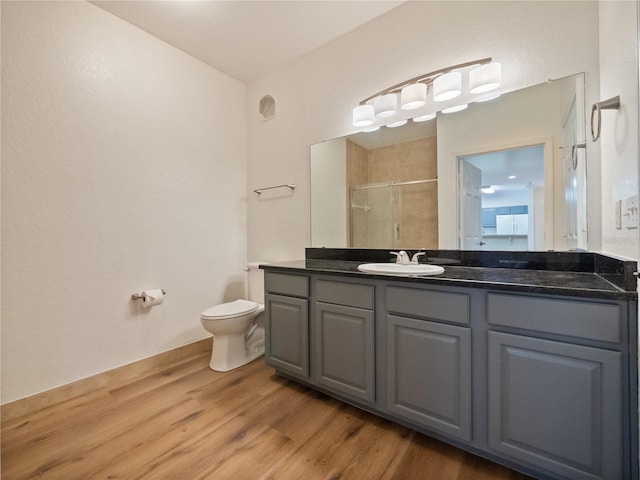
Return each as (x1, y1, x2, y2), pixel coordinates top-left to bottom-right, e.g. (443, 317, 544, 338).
(600, 1, 639, 258)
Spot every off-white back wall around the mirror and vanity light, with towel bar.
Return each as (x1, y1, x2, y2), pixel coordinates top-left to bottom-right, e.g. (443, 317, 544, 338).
(247, 1, 600, 260)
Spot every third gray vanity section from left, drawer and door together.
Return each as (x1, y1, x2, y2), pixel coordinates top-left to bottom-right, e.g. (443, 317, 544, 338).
(386, 287, 471, 441)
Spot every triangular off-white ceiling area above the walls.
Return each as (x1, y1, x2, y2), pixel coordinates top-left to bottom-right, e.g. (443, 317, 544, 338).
(91, 0, 404, 83)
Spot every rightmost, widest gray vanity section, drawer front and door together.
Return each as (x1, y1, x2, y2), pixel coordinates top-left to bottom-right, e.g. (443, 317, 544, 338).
(488, 294, 626, 480)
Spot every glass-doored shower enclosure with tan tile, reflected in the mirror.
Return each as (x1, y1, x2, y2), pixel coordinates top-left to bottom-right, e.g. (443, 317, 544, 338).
(349, 179, 438, 249)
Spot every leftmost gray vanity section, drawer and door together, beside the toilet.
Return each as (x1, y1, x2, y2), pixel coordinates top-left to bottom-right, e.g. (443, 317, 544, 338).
(265, 272, 309, 378)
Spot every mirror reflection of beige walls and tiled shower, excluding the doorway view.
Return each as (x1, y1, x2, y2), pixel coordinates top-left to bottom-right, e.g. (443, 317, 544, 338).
(310, 74, 587, 250)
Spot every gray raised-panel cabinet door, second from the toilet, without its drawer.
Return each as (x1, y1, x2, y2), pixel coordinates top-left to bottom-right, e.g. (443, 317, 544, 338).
(314, 302, 375, 402)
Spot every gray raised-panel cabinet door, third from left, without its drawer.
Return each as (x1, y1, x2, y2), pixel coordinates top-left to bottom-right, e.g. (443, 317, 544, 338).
(387, 315, 471, 440)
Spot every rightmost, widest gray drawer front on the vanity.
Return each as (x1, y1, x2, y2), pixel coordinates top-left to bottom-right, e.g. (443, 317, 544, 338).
(487, 293, 621, 343)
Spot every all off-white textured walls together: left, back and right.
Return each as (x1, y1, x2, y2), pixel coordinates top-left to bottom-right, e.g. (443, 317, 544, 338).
(1, 1, 638, 403)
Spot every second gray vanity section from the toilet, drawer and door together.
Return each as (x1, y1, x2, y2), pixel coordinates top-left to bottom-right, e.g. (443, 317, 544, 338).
(311, 279, 375, 403)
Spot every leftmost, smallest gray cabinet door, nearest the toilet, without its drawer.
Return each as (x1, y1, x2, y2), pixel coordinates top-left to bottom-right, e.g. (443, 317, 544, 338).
(265, 295, 309, 377)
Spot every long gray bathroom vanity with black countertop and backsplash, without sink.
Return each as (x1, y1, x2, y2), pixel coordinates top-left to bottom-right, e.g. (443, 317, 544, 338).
(262, 249, 638, 479)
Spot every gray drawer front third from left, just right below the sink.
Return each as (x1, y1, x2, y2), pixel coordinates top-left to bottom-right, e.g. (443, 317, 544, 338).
(386, 287, 469, 325)
